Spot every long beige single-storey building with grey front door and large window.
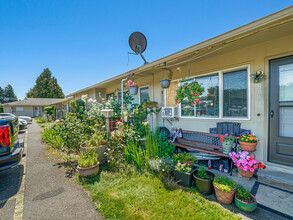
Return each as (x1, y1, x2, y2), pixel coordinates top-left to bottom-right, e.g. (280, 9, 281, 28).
(69, 7, 293, 169)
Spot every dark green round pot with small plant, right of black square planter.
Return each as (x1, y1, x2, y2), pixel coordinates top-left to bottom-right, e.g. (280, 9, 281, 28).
(193, 165, 215, 195)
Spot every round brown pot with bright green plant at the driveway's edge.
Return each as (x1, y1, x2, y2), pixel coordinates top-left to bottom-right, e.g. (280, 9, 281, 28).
(77, 149, 99, 177)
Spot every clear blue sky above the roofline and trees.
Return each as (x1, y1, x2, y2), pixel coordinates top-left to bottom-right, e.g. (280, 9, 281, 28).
(0, 0, 292, 99)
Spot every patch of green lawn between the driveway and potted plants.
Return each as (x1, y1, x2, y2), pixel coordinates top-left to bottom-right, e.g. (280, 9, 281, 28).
(76, 172, 239, 220)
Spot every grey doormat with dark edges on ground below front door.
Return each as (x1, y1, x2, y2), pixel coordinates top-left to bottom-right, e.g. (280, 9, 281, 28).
(251, 181, 293, 220)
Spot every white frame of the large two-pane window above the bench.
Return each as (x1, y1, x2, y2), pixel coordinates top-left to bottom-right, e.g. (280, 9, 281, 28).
(178, 64, 251, 121)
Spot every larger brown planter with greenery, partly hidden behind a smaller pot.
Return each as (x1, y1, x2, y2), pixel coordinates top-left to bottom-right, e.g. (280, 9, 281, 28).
(80, 131, 108, 164)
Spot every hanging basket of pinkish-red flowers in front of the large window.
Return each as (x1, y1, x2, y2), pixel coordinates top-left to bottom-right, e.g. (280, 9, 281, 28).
(175, 80, 204, 105)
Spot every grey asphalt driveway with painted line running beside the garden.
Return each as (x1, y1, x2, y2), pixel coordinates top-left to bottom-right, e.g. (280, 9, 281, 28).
(0, 122, 102, 220)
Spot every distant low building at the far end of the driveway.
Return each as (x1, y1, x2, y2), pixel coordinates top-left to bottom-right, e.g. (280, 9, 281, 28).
(2, 98, 68, 117)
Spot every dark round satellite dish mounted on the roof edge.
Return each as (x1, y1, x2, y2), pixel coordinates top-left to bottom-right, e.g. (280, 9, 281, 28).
(128, 32, 148, 64)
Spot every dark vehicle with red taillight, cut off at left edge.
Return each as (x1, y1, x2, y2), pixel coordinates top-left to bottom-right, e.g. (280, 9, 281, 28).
(0, 113, 24, 171)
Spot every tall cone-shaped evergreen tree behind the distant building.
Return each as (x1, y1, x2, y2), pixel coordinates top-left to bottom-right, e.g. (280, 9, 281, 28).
(26, 68, 64, 98)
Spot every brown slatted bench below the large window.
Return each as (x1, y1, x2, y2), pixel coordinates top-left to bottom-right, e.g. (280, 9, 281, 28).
(170, 130, 237, 158)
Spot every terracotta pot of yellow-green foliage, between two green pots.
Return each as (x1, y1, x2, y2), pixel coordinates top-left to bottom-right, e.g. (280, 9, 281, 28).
(213, 177, 237, 204)
